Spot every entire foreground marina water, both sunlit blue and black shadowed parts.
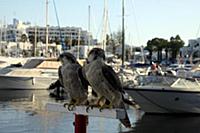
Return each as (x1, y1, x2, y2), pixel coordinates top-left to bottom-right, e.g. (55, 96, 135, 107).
(0, 100, 200, 133)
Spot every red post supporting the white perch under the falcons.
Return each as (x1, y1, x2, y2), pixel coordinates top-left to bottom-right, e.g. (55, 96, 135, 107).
(75, 114, 88, 133)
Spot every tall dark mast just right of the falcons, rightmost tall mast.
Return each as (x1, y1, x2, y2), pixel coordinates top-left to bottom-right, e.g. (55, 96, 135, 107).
(122, 0, 125, 67)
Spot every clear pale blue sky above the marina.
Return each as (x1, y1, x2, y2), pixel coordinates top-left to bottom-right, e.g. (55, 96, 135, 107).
(0, 0, 200, 46)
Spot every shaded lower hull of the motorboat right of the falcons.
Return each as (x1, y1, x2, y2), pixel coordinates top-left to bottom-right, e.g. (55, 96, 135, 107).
(125, 88, 200, 113)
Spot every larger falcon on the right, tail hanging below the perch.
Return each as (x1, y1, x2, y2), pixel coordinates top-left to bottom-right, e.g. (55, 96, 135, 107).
(84, 48, 131, 127)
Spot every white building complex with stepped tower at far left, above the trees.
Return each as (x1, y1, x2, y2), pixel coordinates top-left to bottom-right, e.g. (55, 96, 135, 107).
(0, 19, 97, 45)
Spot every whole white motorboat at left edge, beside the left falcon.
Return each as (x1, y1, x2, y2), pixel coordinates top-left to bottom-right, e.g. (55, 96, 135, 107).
(0, 57, 60, 99)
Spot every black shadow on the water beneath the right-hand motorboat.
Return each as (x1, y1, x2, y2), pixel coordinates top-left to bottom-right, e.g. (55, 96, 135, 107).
(132, 115, 200, 133)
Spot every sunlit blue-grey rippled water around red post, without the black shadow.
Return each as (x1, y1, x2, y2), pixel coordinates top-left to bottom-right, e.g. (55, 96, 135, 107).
(0, 101, 139, 133)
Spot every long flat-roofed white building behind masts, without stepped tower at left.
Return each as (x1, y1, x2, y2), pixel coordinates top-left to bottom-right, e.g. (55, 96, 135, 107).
(26, 26, 96, 45)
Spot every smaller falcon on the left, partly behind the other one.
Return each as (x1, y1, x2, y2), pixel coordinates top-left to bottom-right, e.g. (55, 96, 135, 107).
(58, 52, 88, 110)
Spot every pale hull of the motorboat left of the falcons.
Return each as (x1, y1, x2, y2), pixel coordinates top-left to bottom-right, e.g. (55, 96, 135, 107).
(0, 76, 57, 101)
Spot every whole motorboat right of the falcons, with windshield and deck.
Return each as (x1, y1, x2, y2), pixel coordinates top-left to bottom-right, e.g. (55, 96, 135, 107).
(124, 75, 200, 114)
